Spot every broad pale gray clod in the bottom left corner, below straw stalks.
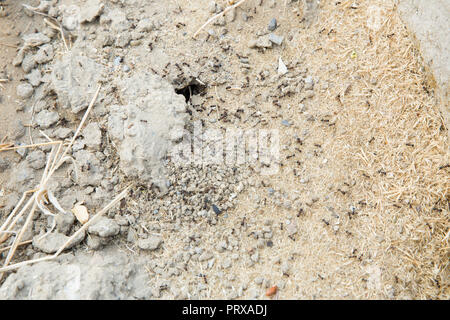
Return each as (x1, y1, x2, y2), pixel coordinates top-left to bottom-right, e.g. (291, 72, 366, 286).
(0, 248, 152, 300)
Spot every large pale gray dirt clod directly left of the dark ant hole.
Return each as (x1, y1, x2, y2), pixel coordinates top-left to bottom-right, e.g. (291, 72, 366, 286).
(108, 73, 187, 192)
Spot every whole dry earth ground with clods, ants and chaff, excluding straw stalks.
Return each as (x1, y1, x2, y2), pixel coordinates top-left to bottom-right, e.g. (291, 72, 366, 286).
(0, 0, 449, 299)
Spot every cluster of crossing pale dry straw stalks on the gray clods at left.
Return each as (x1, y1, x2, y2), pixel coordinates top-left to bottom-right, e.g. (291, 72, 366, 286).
(0, 86, 130, 279)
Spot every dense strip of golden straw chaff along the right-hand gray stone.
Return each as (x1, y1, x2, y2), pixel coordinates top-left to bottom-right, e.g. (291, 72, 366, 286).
(312, 1, 450, 299)
